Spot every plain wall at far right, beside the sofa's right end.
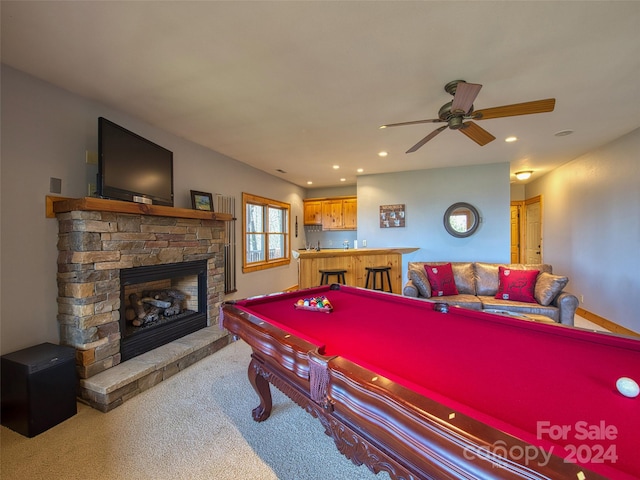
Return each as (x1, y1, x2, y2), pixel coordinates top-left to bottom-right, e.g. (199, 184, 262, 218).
(526, 129, 640, 332)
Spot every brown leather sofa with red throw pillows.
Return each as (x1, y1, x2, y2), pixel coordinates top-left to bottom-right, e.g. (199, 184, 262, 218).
(402, 262, 578, 325)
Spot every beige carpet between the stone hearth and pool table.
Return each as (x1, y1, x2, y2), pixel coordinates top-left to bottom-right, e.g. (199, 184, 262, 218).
(0, 341, 389, 480)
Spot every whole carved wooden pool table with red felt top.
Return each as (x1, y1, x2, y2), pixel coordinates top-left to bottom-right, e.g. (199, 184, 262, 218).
(221, 285, 640, 480)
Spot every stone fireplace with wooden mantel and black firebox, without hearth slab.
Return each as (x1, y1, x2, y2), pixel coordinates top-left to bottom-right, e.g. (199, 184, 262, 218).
(48, 197, 231, 411)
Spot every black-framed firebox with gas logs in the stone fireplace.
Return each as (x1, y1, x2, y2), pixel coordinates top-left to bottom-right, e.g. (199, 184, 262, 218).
(120, 260, 207, 361)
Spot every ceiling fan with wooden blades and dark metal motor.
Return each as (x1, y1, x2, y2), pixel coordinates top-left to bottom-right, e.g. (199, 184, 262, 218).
(380, 80, 556, 153)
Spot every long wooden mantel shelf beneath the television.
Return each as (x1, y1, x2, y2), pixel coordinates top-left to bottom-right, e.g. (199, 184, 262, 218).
(46, 195, 233, 222)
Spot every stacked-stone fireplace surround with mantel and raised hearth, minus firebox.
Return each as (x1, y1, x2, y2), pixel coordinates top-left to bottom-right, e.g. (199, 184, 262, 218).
(47, 197, 231, 411)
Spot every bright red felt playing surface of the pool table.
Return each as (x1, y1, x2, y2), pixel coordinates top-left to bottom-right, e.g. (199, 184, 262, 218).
(236, 286, 640, 478)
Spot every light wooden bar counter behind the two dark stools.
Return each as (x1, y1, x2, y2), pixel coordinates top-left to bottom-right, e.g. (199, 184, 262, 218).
(298, 247, 418, 294)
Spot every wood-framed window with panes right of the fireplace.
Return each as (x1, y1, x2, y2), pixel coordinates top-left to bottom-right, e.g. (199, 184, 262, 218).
(242, 193, 291, 273)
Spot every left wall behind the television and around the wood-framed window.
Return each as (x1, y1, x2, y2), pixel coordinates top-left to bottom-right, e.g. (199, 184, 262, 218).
(0, 65, 305, 353)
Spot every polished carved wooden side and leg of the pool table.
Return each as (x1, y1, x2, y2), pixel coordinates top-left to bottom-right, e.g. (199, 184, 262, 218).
(221, 303, 605, 480)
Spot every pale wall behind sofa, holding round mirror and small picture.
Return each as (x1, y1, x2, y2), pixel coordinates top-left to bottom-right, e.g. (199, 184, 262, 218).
(358, 163, 510, 279)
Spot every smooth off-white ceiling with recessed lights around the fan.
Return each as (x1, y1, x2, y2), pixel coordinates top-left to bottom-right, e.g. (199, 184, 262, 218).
(1, 1, 640, 188)
